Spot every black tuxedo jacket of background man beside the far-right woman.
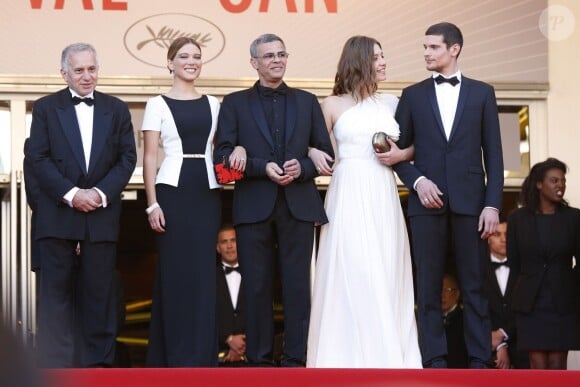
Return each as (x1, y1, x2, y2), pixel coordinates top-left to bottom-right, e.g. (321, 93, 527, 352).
(485, 260, 516, 340)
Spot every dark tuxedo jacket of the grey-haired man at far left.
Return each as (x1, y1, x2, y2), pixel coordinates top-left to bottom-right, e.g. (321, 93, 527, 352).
(26, 88, 137, 242)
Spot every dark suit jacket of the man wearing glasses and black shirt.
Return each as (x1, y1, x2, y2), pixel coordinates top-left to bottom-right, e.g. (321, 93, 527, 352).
(214, 85, 334, 225)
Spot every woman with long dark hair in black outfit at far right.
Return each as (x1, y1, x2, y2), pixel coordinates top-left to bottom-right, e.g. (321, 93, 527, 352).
(507, 158, 580, 369)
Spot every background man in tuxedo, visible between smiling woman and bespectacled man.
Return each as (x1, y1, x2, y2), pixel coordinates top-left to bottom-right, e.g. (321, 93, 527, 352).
(216, 225, 246, 365)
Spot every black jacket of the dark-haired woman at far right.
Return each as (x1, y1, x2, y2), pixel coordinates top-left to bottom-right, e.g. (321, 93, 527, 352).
(507, 206, 580, 313)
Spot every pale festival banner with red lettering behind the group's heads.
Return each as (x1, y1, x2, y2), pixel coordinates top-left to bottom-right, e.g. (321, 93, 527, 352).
(0, 0, 548, 82)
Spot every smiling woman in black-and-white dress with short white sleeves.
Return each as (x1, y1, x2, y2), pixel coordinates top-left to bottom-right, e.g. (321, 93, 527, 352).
(142, 37, 245, 367)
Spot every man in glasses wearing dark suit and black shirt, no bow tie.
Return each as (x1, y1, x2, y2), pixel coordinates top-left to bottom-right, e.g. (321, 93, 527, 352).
(214, 34, 333, 366)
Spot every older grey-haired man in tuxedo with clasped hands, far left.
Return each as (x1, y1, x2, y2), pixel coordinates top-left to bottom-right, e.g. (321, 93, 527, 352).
(26, 43, 137, 368)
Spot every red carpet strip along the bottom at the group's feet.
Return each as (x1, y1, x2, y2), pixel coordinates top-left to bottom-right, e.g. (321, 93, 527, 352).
(43, 368, 580, 387)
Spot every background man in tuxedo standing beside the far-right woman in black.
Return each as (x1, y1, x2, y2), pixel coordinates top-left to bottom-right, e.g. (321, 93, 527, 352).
(486, 221, 530, 369)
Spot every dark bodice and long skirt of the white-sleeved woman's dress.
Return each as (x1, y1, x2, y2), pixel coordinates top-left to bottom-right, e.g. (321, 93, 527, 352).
(147, 96, 221, 367)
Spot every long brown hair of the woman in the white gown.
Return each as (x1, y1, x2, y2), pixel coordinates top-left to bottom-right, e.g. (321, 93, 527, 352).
(332, 36, 382, 98)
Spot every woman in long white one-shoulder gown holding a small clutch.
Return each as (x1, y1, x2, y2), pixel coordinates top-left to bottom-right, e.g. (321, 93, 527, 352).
(307, 36, 421, 368)
